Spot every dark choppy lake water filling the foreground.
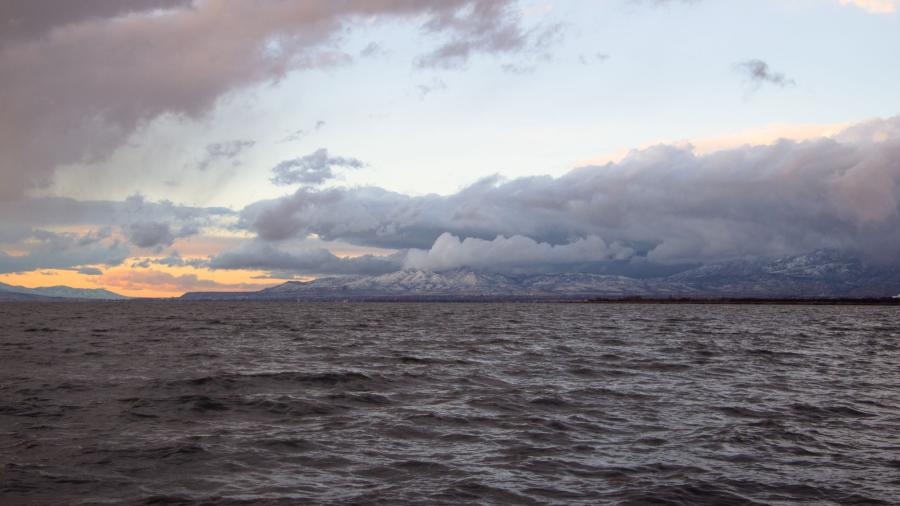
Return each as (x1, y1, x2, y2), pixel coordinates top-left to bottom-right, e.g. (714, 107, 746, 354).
(0, 302, 900, 504)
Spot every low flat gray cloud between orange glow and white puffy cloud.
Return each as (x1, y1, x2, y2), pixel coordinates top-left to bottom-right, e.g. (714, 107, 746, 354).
(209, 241, 402, 275)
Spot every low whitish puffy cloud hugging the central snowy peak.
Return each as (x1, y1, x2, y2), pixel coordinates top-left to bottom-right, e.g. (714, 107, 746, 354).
(403, 233, 633, 271)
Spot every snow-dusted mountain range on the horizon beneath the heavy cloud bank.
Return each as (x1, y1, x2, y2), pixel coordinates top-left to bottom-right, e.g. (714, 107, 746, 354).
(182, 250, 900, 300)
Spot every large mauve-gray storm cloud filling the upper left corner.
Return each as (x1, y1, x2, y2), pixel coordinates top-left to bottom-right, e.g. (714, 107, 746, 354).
(0, 0, 540, 199)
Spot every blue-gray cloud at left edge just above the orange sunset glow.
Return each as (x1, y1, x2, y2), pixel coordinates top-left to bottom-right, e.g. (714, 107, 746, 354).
(0, 230, 128, 274)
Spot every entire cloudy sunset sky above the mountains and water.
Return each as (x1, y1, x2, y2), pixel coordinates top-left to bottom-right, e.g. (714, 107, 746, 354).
(0, 0, 900, 297)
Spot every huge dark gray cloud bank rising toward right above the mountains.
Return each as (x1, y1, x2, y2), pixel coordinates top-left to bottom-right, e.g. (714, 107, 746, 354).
(241, 118, 900, 262)
